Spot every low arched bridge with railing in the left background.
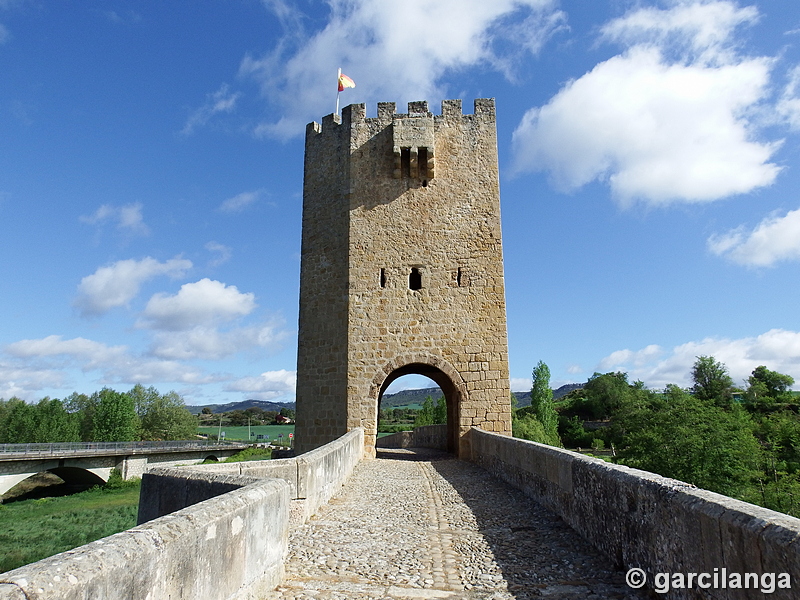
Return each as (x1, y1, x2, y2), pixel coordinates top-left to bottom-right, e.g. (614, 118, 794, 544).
(0, 441, 248, 496)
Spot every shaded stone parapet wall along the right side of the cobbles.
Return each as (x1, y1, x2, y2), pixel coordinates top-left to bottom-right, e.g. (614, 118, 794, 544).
(470, 429, 800, 600)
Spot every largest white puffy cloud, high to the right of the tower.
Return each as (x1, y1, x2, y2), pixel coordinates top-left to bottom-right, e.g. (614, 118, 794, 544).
(513, 1, 780, 205)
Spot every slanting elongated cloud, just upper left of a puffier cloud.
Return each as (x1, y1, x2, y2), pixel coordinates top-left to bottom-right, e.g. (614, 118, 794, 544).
(73, 256, 192, 316)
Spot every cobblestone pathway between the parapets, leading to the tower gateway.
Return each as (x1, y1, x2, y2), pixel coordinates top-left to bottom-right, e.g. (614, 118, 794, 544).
(269, 450, 648, 600)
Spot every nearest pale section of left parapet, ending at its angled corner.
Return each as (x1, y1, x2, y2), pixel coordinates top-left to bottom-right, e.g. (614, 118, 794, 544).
(0, 476, 289, 600)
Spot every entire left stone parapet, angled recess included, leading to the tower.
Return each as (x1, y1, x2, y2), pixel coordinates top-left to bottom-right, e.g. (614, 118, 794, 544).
(0, 429, 364, 600)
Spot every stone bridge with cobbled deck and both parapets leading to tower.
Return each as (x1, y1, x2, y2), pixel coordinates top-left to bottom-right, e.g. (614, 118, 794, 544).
(0, 426, 800, 600)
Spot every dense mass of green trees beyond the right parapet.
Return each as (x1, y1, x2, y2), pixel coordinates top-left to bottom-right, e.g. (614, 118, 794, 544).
(514, 356, 800, 516)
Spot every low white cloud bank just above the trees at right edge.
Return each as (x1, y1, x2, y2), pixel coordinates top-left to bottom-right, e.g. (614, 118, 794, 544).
(597, 329, 800, 389)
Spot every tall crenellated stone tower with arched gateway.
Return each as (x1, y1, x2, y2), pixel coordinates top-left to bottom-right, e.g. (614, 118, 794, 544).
(295, 99, 511, 456)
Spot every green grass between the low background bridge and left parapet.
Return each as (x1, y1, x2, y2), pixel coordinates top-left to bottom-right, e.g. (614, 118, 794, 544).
(0, 481, 139, 573)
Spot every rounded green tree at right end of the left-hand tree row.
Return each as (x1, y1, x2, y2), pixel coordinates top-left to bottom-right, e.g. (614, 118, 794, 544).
(128, 384, 198, 440)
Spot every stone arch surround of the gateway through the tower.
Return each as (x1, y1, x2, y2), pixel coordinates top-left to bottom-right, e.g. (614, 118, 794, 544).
(364, 353, 467, 454)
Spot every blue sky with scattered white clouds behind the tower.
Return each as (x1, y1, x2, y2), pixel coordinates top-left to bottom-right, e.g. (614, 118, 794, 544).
(0, 0, 800, 404)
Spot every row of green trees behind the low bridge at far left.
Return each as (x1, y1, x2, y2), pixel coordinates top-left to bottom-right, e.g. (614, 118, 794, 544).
(0, 385, 198, 444)
